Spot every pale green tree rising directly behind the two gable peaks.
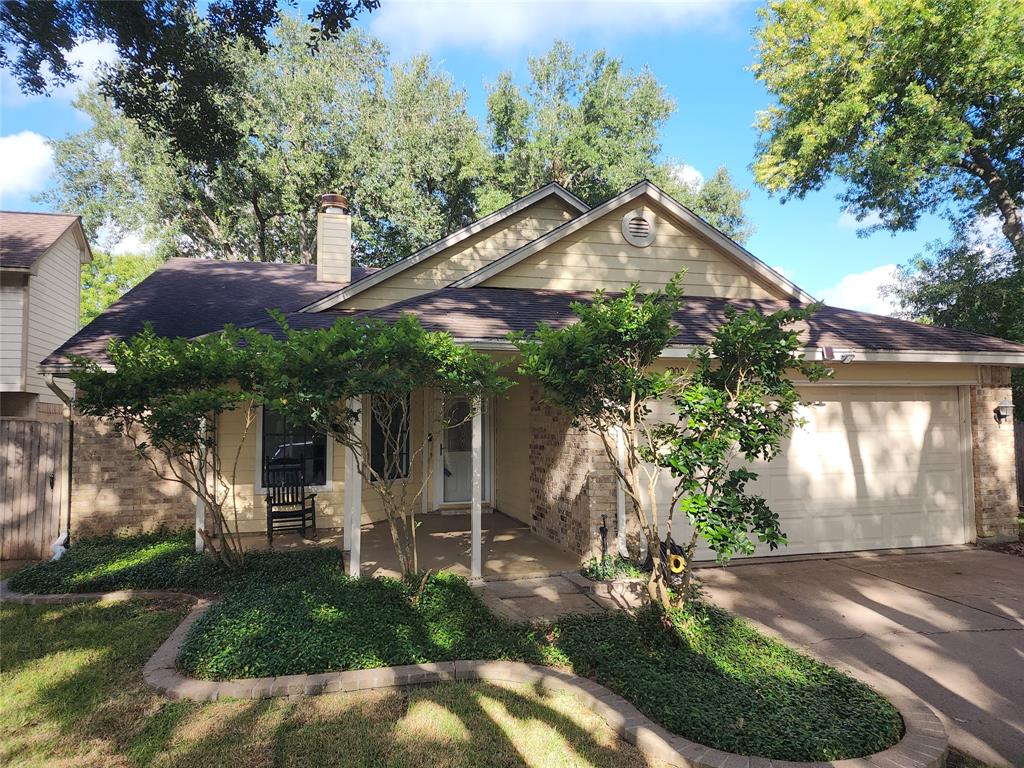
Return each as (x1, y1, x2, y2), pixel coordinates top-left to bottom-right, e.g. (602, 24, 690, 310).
(480, 41, 751, 242)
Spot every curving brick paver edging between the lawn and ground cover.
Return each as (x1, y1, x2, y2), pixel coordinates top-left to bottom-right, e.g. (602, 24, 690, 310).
(0, 584, 947, 768)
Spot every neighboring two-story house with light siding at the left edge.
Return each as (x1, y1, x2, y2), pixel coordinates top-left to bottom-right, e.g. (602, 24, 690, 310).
(0, 211, 92, 419)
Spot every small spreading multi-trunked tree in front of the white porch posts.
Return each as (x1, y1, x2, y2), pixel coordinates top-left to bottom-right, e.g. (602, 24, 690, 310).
(243, 314, 512, 575)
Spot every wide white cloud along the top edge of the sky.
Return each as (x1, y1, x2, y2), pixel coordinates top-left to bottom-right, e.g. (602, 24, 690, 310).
(370, 0, 737, 55)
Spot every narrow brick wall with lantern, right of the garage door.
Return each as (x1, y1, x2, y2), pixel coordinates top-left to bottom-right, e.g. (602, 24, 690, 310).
(971, 366, 1020, 542)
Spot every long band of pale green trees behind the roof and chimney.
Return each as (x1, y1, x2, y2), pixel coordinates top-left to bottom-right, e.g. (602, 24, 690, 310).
(43, 33, 750, 266)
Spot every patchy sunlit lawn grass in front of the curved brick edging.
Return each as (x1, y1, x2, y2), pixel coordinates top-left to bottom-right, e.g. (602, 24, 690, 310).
(0, 601, 652, 768)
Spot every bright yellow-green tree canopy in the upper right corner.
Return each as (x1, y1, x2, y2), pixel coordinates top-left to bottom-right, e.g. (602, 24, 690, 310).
(754, 0, 1024, 268)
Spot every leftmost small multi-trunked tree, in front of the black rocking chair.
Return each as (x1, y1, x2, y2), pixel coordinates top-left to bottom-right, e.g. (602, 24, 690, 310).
(71, 326, 260, 567)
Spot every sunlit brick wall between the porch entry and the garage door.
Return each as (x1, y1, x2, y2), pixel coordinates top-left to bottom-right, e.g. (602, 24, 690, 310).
(529, 386, 615, 561)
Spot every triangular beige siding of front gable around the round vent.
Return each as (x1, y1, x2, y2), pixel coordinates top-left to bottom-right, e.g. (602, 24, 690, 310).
(482, 201, 786, 299)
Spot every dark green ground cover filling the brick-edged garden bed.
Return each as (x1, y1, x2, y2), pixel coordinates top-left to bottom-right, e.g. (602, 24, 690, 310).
(11, 535, 902, 760)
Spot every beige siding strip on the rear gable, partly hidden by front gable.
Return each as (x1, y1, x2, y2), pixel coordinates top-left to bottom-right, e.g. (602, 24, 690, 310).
(340, 197, 575, 309)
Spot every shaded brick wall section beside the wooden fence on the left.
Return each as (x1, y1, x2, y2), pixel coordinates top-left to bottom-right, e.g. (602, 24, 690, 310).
(71, 416, 196, 537)
